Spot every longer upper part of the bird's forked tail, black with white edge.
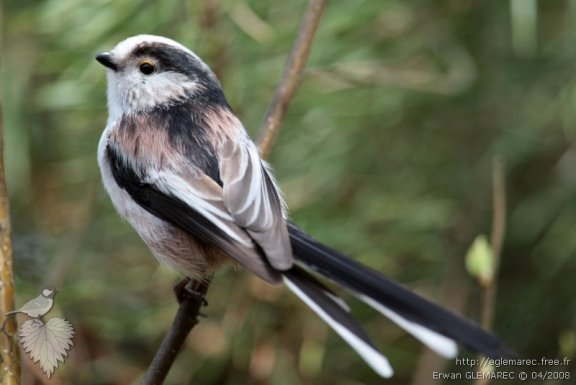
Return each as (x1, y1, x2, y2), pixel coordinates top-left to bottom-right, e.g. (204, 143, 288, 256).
(288, 223, 511, 358)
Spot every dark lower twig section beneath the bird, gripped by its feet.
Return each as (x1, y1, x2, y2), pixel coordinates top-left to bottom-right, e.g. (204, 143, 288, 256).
(142, 280, 210, 385)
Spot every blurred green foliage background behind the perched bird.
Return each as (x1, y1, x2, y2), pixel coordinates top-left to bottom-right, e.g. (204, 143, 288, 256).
(1, 0, 576, 385)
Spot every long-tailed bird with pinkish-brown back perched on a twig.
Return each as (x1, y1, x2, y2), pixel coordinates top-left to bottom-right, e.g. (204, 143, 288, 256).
(95, 35, 509, 378)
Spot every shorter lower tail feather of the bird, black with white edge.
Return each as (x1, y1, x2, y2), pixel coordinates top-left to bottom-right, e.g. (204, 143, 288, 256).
(283, 267, 393, 378)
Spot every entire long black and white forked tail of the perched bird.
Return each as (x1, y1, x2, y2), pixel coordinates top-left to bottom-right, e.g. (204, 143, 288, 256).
(284, 220, 511, 377)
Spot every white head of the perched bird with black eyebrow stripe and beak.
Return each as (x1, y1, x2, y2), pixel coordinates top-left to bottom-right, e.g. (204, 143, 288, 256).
(96, 35, 221, 119)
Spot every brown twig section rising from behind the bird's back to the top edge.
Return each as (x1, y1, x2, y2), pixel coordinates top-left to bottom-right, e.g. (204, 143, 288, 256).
(258, 0, 328, 159)
